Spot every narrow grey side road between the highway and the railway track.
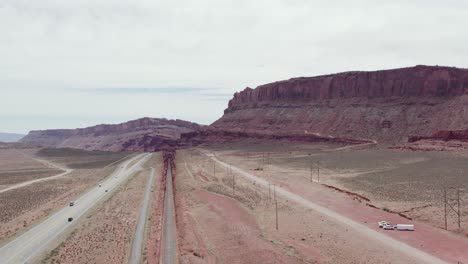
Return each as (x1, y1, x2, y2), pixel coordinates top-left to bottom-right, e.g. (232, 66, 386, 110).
(128, 168, 154, 264)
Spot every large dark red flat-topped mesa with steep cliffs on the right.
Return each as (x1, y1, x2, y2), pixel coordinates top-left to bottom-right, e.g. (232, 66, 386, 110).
(211, 66, 468, 143)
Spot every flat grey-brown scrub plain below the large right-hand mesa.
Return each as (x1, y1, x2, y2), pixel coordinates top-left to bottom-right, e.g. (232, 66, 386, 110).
(209, 143, 468, 234)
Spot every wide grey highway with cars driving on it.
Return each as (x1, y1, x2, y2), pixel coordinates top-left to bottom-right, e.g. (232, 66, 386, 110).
(0, 154, 151, 264)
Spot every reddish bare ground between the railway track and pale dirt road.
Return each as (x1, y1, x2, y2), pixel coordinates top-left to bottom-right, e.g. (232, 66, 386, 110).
(176, 148, 434, 263)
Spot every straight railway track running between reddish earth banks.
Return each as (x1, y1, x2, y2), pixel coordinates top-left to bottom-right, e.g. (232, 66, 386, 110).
(162, 166, 177, 264)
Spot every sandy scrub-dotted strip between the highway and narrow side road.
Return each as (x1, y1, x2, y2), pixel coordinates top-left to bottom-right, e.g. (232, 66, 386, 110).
(42, 166, 148, 263)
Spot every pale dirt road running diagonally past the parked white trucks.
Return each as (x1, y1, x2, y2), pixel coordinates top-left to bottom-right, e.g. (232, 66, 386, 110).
(207, 151, 446, 264)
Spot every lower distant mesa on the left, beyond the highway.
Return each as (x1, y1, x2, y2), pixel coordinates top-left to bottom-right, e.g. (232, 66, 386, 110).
(20, 118, 200, 151)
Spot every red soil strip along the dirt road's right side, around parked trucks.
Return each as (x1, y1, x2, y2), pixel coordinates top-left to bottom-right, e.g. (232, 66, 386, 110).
(209, 148, 468, 263)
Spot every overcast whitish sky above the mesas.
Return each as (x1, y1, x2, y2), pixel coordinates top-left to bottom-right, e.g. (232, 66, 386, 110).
(0, 0, 468, 133)
